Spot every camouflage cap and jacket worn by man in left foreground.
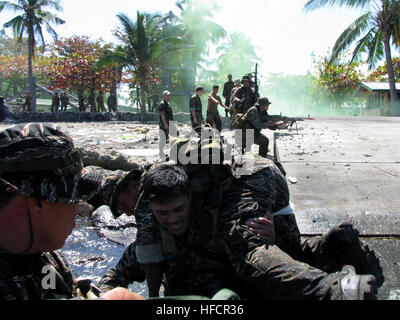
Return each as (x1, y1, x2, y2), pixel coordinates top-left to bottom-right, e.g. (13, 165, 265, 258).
(0, 124, 99, 300)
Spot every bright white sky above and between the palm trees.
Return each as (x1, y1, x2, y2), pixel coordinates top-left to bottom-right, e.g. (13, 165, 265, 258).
(0, 0, 380, 74)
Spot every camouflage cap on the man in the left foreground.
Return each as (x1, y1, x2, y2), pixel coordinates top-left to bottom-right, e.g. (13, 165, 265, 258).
(0, 124, 97, 203)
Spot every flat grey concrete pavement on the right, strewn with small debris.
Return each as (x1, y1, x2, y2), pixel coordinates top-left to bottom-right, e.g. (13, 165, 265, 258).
(277, 118, 400, 300)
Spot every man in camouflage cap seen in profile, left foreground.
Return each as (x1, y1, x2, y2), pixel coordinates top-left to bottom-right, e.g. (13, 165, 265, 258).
(0, 124, 144, 300)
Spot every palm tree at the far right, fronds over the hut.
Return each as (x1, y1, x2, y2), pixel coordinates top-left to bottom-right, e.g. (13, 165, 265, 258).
(304, 0, 400, 115)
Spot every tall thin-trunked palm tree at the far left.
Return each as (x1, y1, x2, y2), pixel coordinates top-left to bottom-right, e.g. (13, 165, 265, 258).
(0, 0, 65, 112)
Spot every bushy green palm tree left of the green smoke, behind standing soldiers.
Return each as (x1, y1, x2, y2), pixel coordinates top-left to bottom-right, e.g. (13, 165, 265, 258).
(100, 11, 178, 114)
